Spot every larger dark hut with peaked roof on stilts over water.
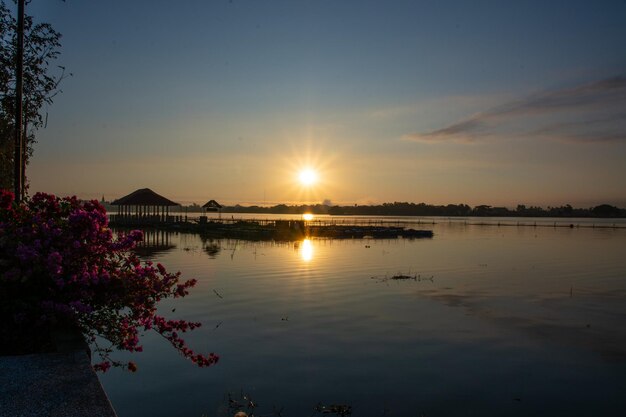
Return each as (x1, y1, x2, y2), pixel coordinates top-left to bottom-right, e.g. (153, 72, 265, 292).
(111, 188, 180, 223)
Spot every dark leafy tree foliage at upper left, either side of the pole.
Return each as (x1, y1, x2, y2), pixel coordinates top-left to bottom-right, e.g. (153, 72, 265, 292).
(0, 0, 65, 189)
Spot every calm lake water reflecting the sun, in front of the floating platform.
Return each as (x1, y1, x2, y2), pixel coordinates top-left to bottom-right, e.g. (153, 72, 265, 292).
(101, 219, 626, 417)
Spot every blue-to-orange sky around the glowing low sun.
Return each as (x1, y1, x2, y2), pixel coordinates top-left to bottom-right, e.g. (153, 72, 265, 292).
(15, 0, 626, 207)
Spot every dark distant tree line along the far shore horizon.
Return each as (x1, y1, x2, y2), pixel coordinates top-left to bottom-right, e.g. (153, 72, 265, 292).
(214, 202, 626, 217)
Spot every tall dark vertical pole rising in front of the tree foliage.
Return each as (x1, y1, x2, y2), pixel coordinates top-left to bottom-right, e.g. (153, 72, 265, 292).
(13, 0, 24, 201)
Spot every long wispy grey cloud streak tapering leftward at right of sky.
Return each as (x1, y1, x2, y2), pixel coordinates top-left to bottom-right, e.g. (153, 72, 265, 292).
(403, 75, 626, 143)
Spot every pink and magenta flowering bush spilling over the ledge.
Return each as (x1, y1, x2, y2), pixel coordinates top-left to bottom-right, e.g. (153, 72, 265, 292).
(0, 191, 219, 372)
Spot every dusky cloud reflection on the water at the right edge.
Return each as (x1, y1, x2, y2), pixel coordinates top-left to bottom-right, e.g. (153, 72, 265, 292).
(417, 289, 626, 362)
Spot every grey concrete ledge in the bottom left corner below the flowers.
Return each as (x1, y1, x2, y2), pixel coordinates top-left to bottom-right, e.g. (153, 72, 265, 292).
(0, 350, 116, 417)
